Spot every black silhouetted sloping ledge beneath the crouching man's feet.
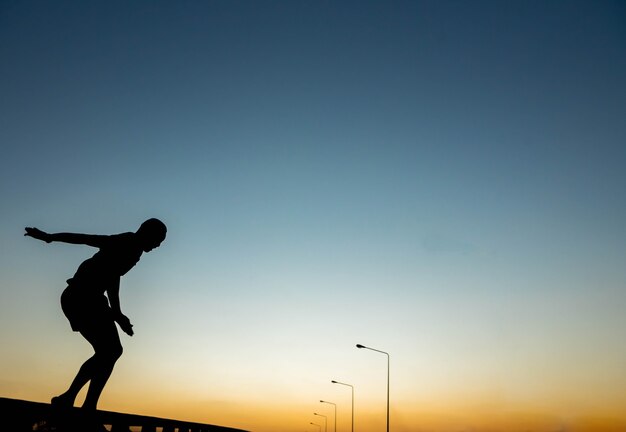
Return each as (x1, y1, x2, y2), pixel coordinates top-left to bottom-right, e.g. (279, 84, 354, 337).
(0, 397, 243, 432)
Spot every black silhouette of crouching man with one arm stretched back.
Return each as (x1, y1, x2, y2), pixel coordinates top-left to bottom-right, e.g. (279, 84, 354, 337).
(24, 219, 167, 410)
